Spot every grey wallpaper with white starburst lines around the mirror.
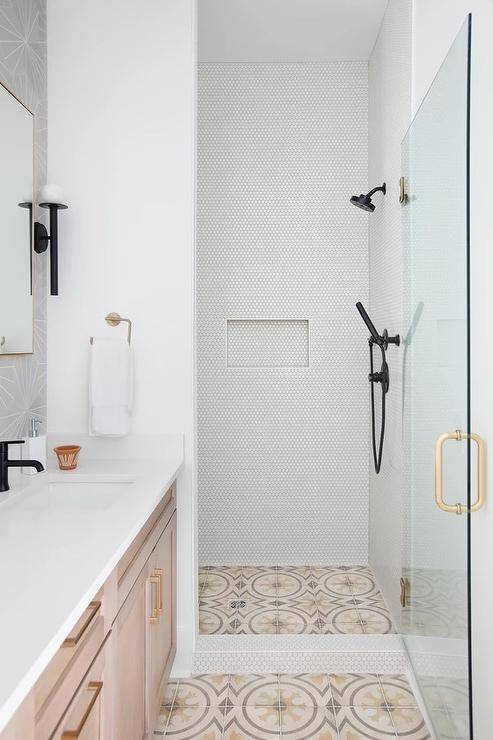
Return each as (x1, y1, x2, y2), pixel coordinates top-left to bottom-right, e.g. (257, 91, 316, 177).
(0, 0, 47, 439)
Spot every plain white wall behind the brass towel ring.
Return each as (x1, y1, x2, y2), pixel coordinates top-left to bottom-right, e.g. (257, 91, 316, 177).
(48, 0, 195, 676)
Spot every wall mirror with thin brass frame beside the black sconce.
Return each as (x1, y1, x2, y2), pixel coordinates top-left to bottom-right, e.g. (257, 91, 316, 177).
(0, 83, 34, 355)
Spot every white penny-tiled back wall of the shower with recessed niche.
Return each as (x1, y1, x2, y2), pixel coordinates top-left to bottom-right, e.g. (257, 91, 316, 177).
(197, 62, 368, 565)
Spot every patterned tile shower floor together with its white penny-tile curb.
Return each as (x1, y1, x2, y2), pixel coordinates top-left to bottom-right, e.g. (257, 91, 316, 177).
(193, 565, 409, 692)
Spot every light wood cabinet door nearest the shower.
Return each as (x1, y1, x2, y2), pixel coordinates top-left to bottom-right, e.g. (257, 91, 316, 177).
(147, 513, 176, 731)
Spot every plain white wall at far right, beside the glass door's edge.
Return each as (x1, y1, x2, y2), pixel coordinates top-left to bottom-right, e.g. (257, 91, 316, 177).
(413, 0, 493, 740)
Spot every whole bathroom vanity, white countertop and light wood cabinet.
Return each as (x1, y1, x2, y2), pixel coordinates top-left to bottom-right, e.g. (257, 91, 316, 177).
(0, 450, 181, 740)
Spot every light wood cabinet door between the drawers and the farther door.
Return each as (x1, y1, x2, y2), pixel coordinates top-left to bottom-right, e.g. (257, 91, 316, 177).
(112, 568, 147, 740)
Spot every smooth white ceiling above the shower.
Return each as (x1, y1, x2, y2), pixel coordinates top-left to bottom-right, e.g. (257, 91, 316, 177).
(197, 0, 388, 62)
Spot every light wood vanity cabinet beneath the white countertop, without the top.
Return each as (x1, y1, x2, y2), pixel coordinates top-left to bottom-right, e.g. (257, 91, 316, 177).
(0, 484, 176, 740)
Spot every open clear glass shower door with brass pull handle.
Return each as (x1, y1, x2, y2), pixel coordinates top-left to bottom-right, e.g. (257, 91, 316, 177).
(401, 18, 481, 740)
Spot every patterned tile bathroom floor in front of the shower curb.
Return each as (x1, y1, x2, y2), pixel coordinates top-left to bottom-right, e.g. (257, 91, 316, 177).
(155, 673, 431, 740)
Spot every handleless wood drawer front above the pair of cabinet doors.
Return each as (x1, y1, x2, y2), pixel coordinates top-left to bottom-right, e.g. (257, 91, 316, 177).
(117, 483, 176, 607)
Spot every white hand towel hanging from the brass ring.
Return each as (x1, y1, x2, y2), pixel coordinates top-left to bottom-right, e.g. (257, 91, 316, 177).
(89, 337, 133, 437)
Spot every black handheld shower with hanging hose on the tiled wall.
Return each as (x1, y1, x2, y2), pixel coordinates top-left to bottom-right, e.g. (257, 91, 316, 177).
(356, 301, 401, 474)
